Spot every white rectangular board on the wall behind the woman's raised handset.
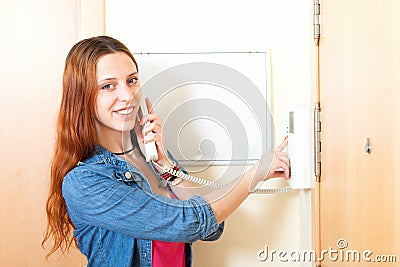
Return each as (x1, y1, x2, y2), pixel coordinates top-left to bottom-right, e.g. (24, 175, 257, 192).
(134, 52, 274, 166)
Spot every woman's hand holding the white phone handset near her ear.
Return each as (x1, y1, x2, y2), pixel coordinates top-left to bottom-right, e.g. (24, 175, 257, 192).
(136, 97, 170, 166)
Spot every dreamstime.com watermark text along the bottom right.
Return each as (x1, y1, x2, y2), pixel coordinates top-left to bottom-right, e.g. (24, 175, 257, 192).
(257, 238, 397, 263)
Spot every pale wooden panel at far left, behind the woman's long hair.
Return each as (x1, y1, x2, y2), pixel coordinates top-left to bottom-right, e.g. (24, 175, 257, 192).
(0, 0, 85, 267)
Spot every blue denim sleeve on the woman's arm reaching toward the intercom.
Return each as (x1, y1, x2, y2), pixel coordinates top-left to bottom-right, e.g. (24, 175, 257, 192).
(62, 167, 220, 242)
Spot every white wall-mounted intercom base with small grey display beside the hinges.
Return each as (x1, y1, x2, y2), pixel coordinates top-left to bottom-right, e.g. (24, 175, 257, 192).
(287, 105, 314, 189)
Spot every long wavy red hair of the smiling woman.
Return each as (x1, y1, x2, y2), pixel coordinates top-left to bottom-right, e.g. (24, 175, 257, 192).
(42, 36, 138, 257)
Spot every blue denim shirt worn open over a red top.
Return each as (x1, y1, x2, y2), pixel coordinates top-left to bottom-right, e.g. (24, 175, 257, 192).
(62, 146, 223, 267)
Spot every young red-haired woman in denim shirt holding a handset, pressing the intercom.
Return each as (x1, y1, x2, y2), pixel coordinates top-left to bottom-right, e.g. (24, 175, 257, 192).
(43, 36, 289, 267)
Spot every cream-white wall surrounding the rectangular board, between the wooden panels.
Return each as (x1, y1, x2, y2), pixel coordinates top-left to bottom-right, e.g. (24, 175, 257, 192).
(105, 0, 314, 266)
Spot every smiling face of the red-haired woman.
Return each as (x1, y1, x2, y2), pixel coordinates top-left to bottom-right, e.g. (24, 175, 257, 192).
(96, 52, 141, 136)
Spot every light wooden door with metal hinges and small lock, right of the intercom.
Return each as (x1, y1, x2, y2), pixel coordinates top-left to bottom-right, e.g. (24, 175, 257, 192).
(319, 0, 400, 267)
